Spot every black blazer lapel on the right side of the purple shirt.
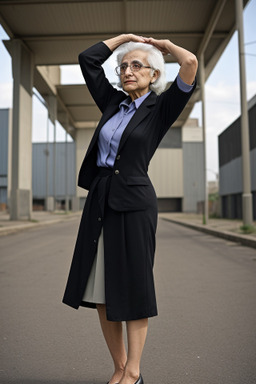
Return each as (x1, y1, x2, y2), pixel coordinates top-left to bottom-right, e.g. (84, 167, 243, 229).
(118, 92, 157, 152)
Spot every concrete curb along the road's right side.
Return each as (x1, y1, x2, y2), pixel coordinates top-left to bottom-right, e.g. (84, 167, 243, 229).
(161, 217, 256, 248)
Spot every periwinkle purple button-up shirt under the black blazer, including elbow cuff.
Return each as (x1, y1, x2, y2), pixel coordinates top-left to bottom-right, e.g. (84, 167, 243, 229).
(97, 75, 193, 168)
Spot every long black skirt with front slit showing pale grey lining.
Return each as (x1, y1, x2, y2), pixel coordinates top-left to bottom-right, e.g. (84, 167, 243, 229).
(63, 168, 157, 321)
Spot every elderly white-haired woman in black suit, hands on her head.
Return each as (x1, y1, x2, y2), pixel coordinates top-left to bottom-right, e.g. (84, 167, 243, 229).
(63, 34, 197, 384)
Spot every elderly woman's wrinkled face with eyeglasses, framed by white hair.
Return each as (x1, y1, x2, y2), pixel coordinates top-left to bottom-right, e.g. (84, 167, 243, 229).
(120, 50, 157, 100)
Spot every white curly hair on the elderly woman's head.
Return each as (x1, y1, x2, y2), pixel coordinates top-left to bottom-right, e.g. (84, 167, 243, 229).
(116, 41, 167, 95)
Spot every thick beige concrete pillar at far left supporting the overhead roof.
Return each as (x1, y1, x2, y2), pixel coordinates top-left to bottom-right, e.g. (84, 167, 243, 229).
(10, 40, 34, 220)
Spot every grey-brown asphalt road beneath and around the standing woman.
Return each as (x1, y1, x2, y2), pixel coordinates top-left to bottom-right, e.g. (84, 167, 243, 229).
(0, 219, 256, 384)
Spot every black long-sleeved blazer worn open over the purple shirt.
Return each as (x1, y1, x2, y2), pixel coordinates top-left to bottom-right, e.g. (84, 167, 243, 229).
(78, 42, 195, 211)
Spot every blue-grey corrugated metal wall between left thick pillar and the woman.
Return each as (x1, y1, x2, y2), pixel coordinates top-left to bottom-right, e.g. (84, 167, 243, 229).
(32, 142, 76, 199)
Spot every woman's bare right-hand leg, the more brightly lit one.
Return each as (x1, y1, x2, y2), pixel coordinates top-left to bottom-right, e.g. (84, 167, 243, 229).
(120, 319, 148, 384)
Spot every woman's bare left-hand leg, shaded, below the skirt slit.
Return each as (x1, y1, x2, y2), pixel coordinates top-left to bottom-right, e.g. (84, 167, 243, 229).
(97, 304, 127, 384)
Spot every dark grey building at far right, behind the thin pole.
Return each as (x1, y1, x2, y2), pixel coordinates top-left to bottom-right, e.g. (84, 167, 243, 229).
(219, 95, 256, 220)
